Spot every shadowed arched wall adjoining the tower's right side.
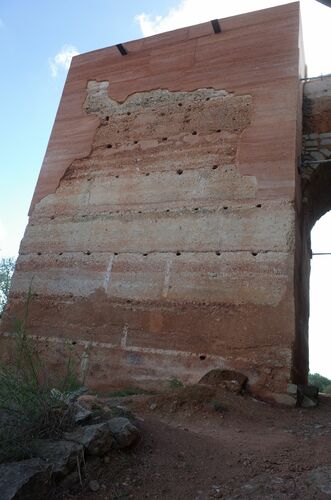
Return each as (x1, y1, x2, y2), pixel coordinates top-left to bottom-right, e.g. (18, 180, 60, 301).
(296, 77, 331, 382)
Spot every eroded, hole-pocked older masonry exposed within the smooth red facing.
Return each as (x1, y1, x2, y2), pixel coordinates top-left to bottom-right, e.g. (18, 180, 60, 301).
(4, 81, 294, 398)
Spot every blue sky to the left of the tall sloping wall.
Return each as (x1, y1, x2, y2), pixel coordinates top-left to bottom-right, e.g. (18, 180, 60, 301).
(0, 0, 180, 255)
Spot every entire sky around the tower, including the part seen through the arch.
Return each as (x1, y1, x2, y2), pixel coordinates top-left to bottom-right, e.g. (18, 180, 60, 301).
(0, 0, 331, 378)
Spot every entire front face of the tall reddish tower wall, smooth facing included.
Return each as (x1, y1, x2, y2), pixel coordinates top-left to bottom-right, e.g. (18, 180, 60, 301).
(2, 3, 300, 397)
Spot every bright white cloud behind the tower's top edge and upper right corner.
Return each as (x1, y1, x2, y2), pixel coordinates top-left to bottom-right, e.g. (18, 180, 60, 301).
(136, 0, 331, 76)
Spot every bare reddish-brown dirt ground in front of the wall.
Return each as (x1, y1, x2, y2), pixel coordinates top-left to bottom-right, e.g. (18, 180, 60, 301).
(56, 386, 331, 500)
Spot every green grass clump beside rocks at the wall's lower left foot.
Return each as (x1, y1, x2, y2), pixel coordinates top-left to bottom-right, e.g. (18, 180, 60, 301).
(0, 292, 81, 462)
